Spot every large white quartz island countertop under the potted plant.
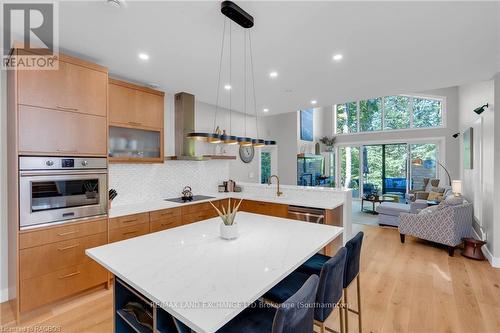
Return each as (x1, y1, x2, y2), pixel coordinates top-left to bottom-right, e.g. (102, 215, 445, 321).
(86, 213, 342, 333)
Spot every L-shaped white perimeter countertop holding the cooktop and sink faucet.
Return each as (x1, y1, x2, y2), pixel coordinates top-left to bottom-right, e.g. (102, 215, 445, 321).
(109, 188, 343, 218)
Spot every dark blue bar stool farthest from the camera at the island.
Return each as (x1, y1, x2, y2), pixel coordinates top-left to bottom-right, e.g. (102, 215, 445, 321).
(298, 231, 364, 333)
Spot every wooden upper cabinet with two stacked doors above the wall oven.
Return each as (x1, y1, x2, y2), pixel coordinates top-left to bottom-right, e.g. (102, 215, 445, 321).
(9, 49, 108, 157)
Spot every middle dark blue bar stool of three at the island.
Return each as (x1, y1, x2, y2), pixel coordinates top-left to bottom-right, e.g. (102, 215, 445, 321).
(264, 247, 347, 333)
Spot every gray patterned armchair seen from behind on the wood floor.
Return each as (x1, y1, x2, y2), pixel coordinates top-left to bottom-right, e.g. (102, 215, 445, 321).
(399, 203, 473, 256)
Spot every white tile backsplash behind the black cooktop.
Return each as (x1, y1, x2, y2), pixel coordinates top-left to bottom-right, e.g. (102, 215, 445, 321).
(109, 160, 229, 205)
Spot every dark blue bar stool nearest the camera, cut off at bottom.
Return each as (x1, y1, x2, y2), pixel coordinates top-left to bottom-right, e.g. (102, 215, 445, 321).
(174, 275, 319, 333)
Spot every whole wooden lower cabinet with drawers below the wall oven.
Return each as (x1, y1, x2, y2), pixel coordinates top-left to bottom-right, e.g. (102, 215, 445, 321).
(19, 219, 108, 312)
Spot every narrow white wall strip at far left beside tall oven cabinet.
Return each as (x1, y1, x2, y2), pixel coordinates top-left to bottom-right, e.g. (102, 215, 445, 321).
(0, 64, 8, 302)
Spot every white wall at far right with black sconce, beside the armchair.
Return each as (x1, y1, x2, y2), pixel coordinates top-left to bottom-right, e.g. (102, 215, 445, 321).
(459, 80, 500, 262)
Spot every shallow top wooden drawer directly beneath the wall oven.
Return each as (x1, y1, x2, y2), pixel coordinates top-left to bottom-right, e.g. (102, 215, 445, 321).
(19, 218, 107, 249)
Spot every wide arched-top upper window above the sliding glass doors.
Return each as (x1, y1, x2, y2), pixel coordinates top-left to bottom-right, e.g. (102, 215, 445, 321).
(335, 95, 444, 134)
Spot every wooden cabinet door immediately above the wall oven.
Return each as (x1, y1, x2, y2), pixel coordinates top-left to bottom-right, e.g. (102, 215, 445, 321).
(19, 105, 107, 156)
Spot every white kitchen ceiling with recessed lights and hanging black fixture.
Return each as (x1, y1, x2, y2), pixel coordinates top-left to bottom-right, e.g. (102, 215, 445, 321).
(59, 1, 500, 114)
